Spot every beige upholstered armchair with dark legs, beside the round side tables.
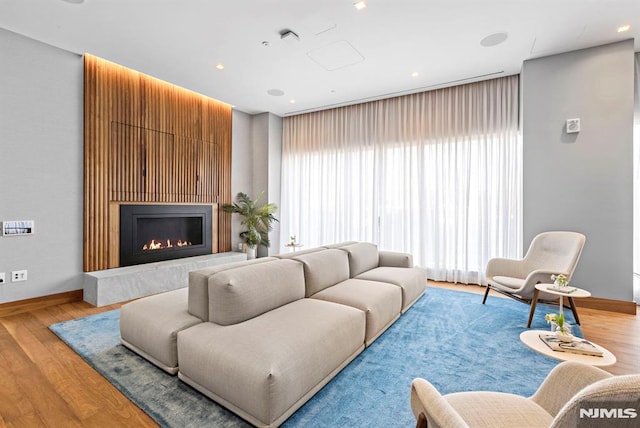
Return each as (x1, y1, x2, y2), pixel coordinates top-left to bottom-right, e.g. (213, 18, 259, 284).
(482, 232, 586, 327)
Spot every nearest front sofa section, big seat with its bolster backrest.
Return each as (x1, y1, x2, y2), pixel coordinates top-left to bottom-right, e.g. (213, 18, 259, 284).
(178, 260, 365, 426)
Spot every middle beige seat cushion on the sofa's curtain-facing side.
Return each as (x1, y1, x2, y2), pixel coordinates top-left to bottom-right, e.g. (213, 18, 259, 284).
(312, 279, 402, 346)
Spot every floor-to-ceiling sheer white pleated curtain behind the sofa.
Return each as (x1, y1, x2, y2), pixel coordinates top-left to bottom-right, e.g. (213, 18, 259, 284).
(281, 76, 522, 283)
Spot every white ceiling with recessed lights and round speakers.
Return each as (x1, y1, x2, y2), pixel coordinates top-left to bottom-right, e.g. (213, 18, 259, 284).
(0, 0, 640, 116)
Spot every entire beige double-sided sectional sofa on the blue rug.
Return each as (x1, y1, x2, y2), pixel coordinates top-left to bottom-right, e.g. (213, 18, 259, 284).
(120, 242, 426, 426)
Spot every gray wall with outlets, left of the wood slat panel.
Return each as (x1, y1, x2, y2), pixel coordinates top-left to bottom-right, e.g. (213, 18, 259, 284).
(0, 29, 83, 303)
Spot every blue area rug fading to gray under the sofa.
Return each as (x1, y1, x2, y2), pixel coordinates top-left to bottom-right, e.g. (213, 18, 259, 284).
(50, 288, 581, 427)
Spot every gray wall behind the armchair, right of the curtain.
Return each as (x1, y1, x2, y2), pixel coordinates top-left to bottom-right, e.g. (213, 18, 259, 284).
(521, 40, 634, 301)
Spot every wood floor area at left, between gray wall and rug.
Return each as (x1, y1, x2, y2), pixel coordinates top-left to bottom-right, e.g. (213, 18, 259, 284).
(0, 302, 157, 427)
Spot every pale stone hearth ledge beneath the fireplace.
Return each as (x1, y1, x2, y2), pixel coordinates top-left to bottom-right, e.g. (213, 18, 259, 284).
(84, 252, 247, 306)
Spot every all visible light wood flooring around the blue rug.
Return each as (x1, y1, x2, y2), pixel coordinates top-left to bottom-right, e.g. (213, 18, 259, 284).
(0, 282, 640, 428)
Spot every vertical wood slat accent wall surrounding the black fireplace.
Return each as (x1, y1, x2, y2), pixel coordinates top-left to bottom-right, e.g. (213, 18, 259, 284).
(83, 54, 232, 272)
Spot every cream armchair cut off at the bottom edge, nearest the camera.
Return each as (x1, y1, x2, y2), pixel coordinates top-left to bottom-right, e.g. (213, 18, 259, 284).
(411, 361, 640, 428)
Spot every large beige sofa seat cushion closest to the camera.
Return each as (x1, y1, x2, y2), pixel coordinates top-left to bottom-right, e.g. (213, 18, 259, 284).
(178, 298, 365, 426)
